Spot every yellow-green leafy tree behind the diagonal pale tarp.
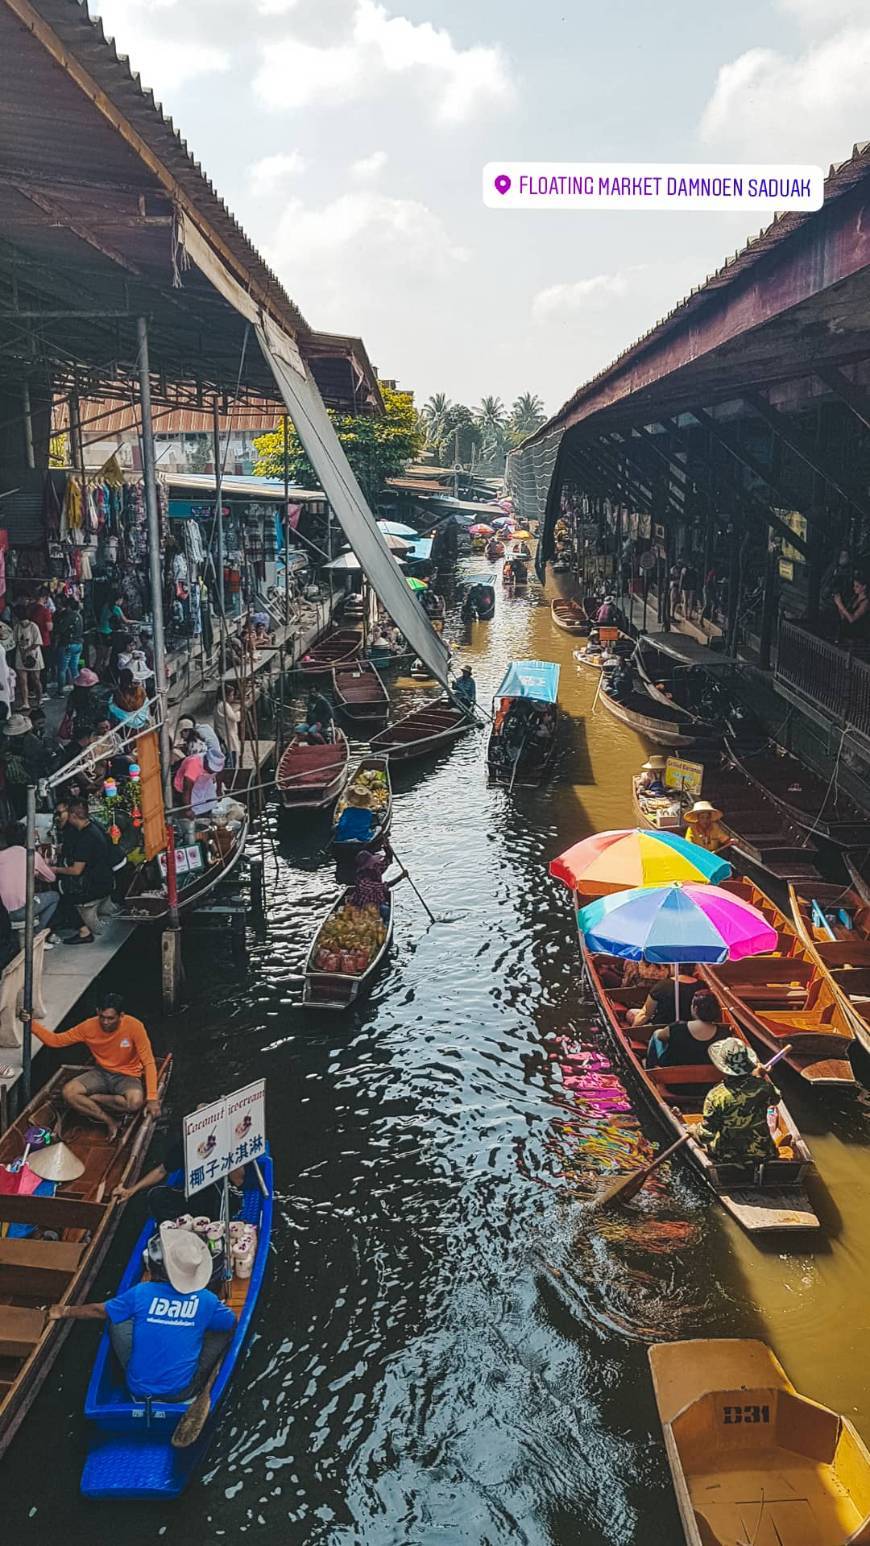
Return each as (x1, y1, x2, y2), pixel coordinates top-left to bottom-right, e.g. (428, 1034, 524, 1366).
(253, 387, 425, 504)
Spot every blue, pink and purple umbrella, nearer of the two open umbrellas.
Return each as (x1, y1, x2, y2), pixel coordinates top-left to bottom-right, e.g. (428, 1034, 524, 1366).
(578, 883, 779, 965)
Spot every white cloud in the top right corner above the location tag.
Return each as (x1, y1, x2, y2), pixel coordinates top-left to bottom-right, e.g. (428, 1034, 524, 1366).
(700, 0, 870, 167)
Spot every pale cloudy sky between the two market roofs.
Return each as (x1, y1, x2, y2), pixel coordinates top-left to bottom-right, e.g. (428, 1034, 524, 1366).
(91, 0, 870, 413)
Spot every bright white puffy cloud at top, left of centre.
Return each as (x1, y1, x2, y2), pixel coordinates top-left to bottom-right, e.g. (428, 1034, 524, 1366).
(253, 0, 515, 124)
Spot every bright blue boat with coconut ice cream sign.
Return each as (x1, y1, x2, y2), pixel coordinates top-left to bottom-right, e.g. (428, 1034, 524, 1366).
(82, 1153, 274, 1500)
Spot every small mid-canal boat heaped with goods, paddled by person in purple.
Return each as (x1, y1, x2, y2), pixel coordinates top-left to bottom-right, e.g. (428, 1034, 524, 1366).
(301, 892, 394, 1010)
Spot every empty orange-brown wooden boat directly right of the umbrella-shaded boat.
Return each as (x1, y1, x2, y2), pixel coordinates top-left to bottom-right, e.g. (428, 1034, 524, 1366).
(698, 880, 856, 1088)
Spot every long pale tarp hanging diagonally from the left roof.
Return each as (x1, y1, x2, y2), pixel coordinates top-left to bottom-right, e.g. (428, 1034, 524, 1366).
(257, 320, 450, 686)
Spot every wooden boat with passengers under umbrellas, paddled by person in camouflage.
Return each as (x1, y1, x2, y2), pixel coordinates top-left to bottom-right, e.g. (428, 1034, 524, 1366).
(579, 938, 821, 1235)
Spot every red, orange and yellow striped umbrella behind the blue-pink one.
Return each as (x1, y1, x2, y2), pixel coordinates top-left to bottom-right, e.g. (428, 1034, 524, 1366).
(550, 827, 731, 897)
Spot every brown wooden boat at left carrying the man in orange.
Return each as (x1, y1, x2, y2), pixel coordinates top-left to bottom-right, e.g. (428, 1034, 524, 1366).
(0, 1057, 172, 1455)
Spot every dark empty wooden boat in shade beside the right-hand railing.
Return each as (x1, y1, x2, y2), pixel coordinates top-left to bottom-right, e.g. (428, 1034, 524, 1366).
(726, 739, 870, 849)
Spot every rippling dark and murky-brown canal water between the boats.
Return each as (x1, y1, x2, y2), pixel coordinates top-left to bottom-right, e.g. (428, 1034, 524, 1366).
(2, 562, 870, 1546)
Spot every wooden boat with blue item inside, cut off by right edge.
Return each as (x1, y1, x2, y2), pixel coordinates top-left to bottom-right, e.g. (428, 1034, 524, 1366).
(788, 883, 870, 1053)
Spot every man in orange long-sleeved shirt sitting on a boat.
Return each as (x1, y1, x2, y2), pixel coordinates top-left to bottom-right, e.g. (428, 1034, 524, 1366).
(32, 993, 161, 1138)
